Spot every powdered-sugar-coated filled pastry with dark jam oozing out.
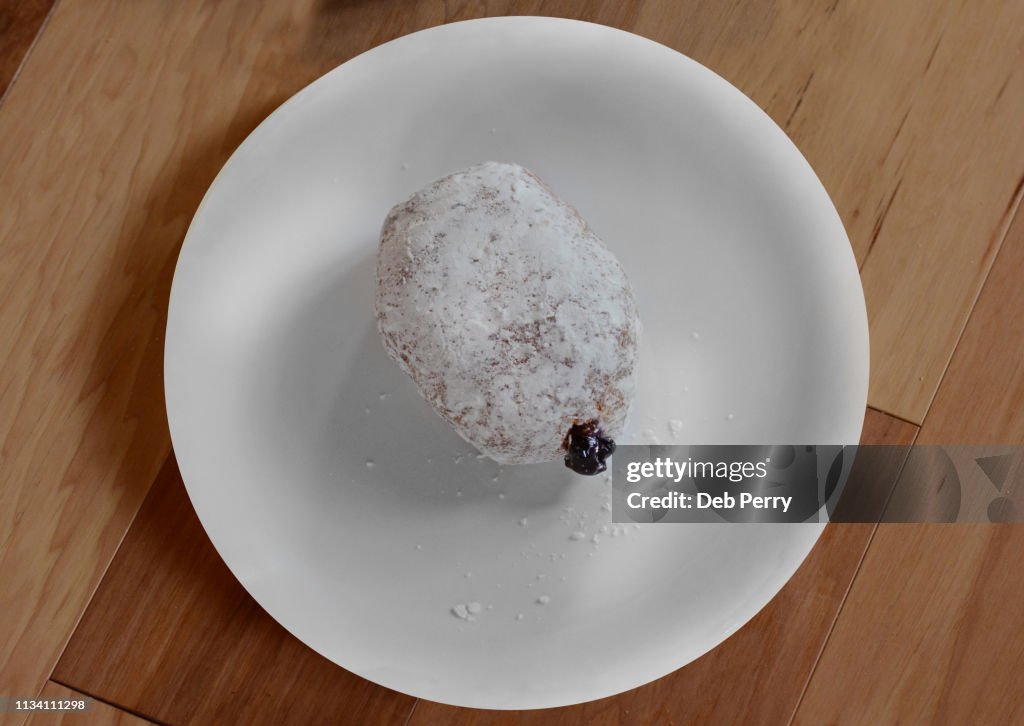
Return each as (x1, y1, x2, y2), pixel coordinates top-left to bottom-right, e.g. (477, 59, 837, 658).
(376, 162, 639, 474)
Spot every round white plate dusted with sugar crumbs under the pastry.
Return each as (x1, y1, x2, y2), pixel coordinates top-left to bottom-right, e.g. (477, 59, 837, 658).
(166, 17, 868, 709)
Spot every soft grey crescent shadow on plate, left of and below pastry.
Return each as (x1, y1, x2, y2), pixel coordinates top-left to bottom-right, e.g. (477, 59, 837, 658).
(250, 248, 577, 510)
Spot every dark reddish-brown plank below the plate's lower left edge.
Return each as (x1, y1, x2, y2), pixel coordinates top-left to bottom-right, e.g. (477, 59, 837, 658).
(53, 457, 414, 725)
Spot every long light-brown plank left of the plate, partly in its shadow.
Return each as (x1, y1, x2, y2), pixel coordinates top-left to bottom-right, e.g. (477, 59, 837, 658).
(0, 0, 456, 693)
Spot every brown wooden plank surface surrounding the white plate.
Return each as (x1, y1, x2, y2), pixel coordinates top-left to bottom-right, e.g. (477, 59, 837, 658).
(0, 0, 1024, 725)
